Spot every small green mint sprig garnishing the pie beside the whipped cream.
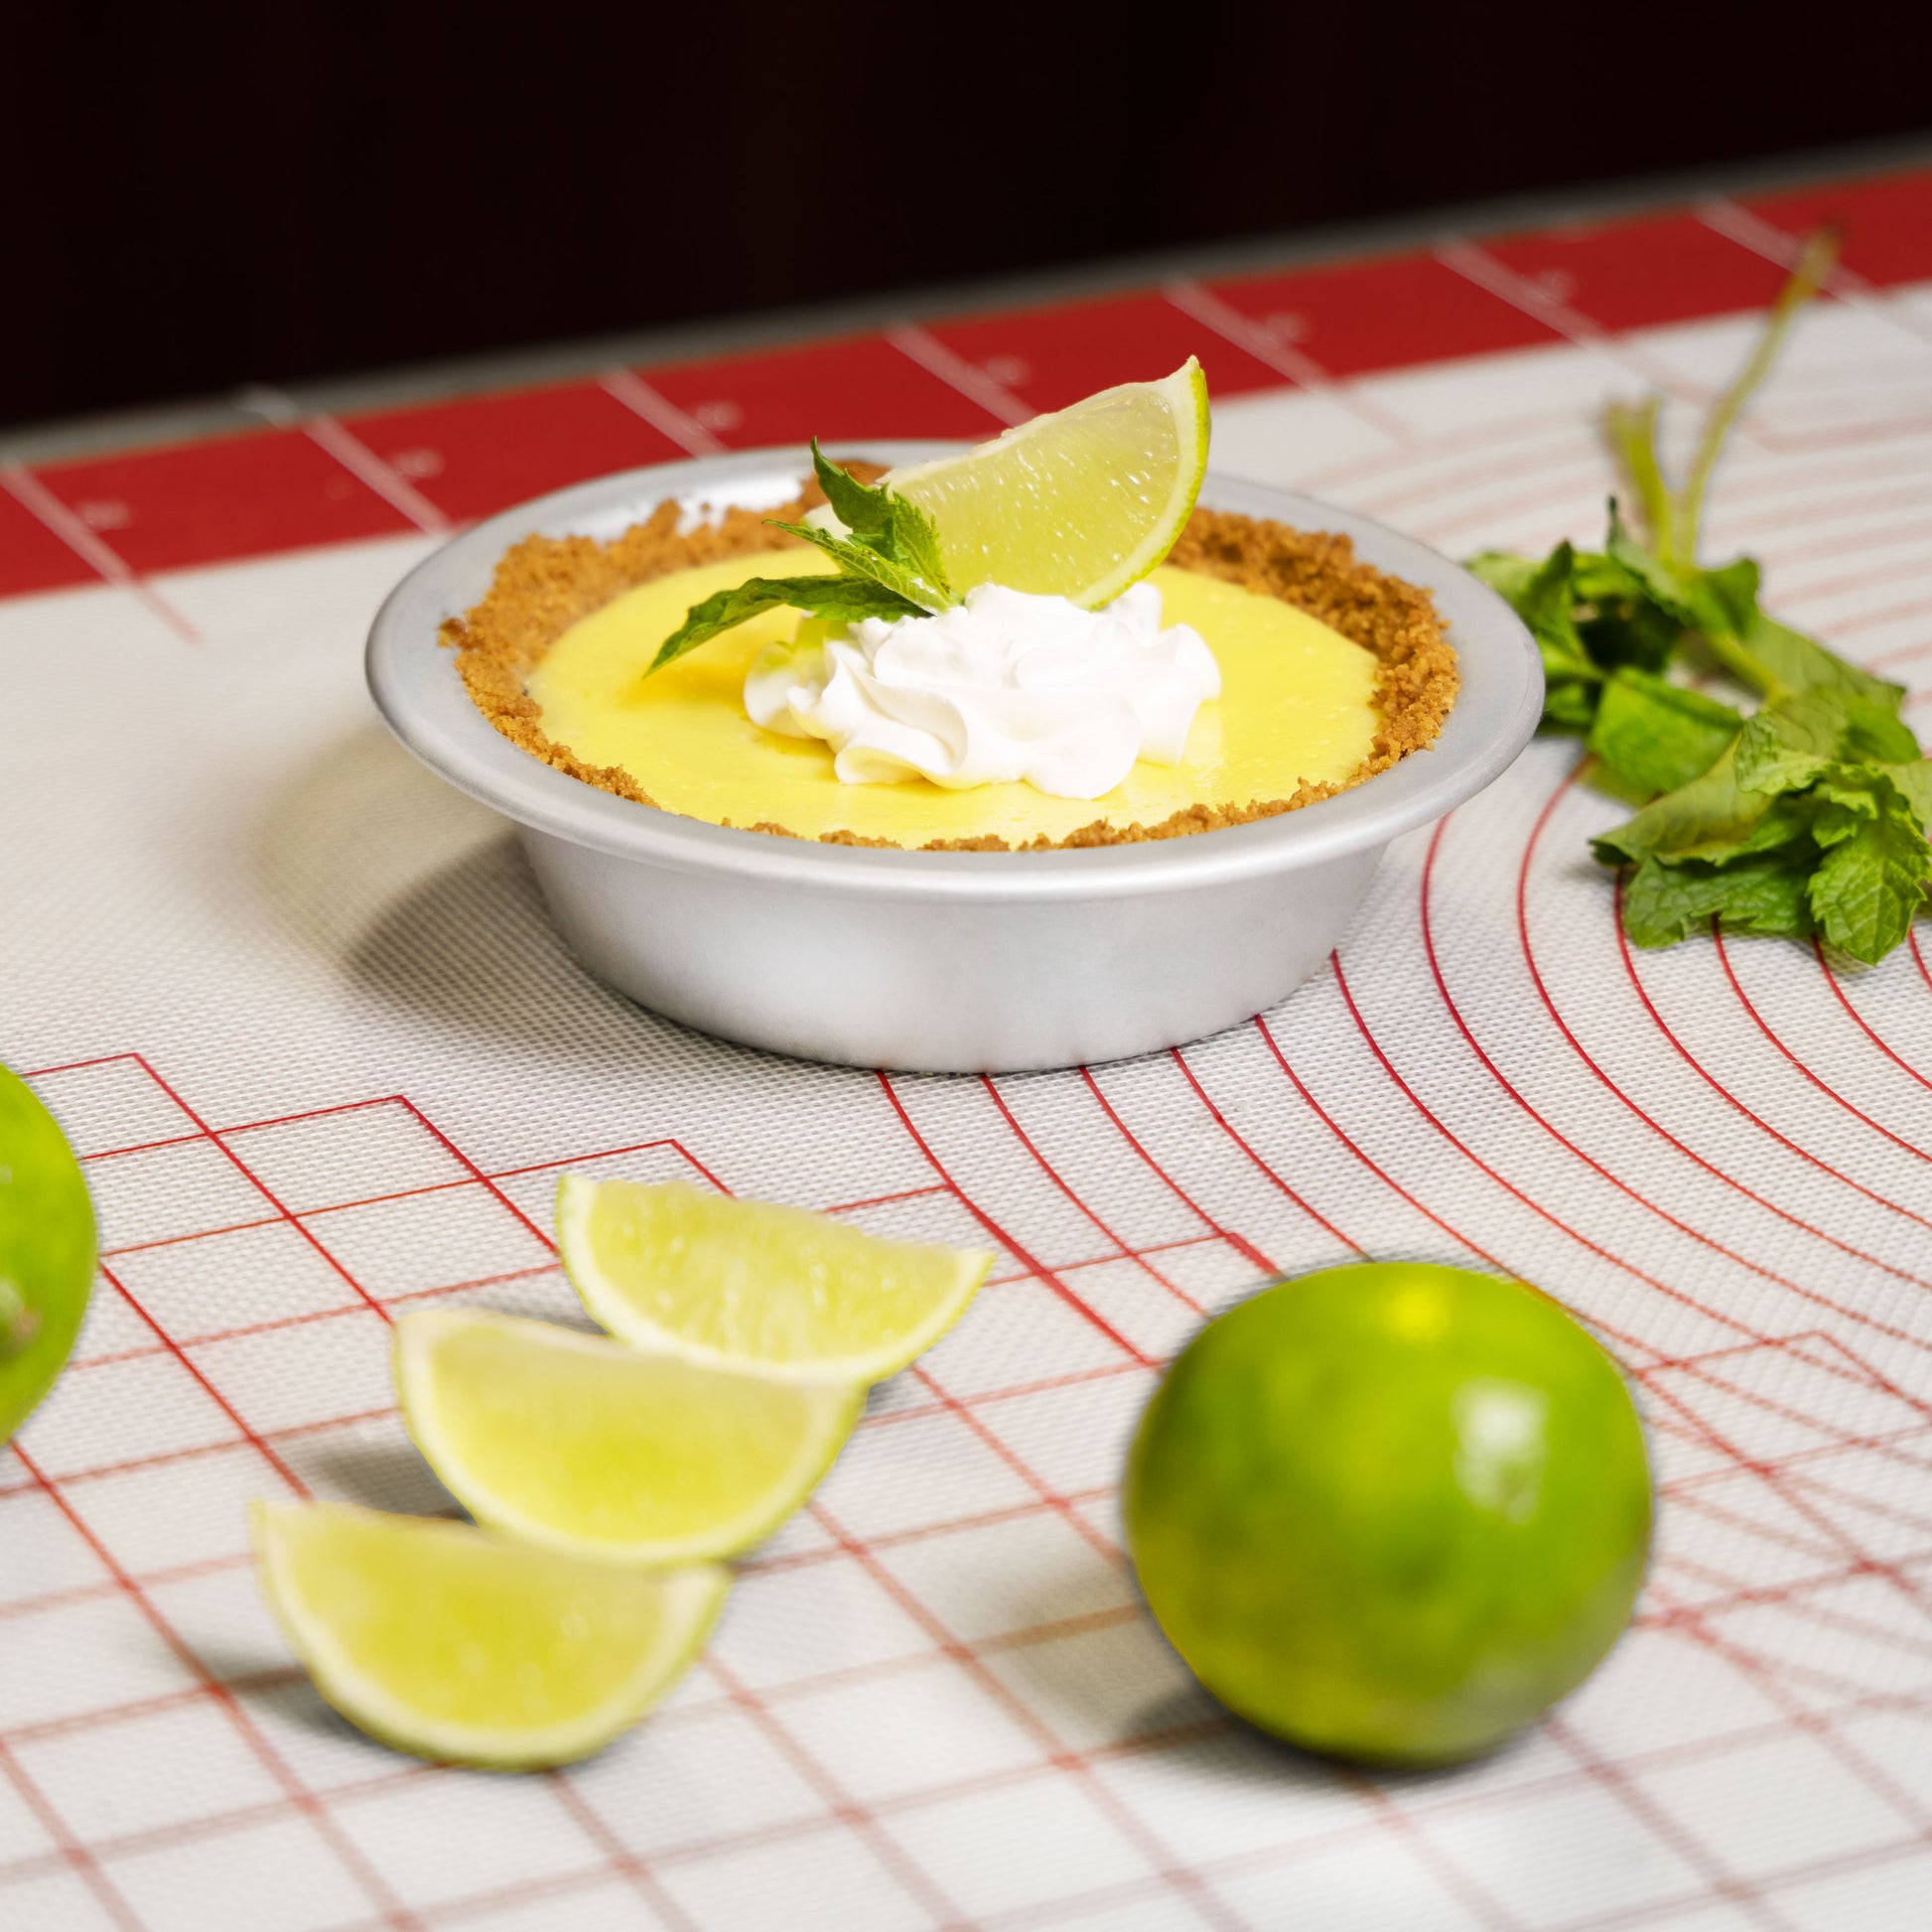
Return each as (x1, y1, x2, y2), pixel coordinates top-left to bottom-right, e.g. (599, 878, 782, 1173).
(645, 437, 958, 676)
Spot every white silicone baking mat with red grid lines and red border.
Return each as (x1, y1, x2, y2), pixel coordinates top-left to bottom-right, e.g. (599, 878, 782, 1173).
(0, 174, 1932, 1932)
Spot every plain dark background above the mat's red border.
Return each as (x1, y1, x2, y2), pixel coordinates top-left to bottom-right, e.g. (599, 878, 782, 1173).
(0, 0, 1932, 423)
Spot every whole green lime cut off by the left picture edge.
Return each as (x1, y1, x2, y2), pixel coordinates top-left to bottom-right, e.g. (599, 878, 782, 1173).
(0, 1066, 94, 1442)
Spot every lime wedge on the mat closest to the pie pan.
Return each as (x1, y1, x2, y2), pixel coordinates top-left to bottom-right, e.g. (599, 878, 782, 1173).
(556, 1174, 993, 1381)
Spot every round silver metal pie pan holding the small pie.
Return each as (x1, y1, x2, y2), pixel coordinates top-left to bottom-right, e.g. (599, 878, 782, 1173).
(369, 443, 1542, 1072)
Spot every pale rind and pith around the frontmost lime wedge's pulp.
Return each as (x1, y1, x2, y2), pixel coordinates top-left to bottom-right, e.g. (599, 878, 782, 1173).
(251, 1501, 731, 1770)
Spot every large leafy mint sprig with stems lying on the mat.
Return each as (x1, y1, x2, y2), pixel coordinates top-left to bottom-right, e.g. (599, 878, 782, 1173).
(1470, 230, 1932, 962)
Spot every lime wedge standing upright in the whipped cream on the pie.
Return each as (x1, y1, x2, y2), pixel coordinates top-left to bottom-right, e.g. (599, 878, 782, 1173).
(885, 355, 1207, 611)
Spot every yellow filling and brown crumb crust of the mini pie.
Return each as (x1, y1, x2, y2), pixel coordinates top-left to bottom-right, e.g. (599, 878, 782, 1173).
(443, 464, 1458, 852)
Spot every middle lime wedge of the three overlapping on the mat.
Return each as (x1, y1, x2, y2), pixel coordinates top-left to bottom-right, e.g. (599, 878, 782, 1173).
(396, 1310, 866, 1563)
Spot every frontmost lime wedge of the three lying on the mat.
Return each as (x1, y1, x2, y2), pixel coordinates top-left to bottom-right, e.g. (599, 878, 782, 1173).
(253, 1503, 729, 1770)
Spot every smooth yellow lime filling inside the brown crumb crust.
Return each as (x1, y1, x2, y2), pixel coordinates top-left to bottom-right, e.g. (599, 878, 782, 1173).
(529, 551, 1376, 846)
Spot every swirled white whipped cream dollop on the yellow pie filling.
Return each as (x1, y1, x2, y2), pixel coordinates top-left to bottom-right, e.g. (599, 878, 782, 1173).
(744, 582, 1221, 798)
